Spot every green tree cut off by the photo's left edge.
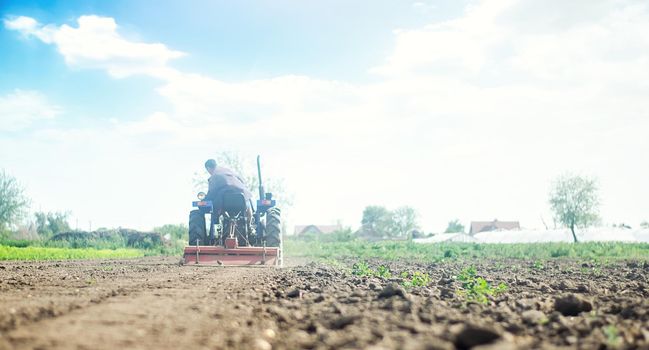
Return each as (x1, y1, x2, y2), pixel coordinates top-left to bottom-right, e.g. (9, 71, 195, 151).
(0, 170, 29, 232)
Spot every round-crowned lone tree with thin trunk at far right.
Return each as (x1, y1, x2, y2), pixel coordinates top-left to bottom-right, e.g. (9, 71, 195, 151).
(550, 175, 599, 243)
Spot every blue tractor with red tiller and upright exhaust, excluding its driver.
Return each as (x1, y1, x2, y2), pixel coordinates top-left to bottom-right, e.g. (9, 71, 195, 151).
(183, 156, 283, 266)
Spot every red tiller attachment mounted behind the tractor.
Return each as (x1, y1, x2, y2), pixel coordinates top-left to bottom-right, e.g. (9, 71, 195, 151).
(184, 245, 281, 266)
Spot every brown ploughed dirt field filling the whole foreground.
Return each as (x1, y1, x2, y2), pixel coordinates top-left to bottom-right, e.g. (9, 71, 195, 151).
(0, 258, 649, 349)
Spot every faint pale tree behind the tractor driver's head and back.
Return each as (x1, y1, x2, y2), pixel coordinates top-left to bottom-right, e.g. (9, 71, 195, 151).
(193, 151, 293, 211)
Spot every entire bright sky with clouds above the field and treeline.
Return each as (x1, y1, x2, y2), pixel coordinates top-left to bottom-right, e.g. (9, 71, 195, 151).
(0, 0, 649, 232)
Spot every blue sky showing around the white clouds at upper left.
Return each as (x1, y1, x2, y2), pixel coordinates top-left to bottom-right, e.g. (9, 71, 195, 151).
(0, 1, 463, 127)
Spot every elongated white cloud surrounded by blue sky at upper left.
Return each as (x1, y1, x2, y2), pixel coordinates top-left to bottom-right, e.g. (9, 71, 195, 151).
(5, 16, 184, 77)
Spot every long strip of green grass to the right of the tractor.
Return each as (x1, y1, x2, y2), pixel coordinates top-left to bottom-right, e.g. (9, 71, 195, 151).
(284, 239, 649, 262)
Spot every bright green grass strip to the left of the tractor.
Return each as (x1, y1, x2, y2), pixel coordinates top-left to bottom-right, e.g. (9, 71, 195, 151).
(0, 245, 145, 260)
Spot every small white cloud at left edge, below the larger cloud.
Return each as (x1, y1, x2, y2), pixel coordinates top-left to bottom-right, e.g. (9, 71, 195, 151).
(0, 90, 61, 132)
